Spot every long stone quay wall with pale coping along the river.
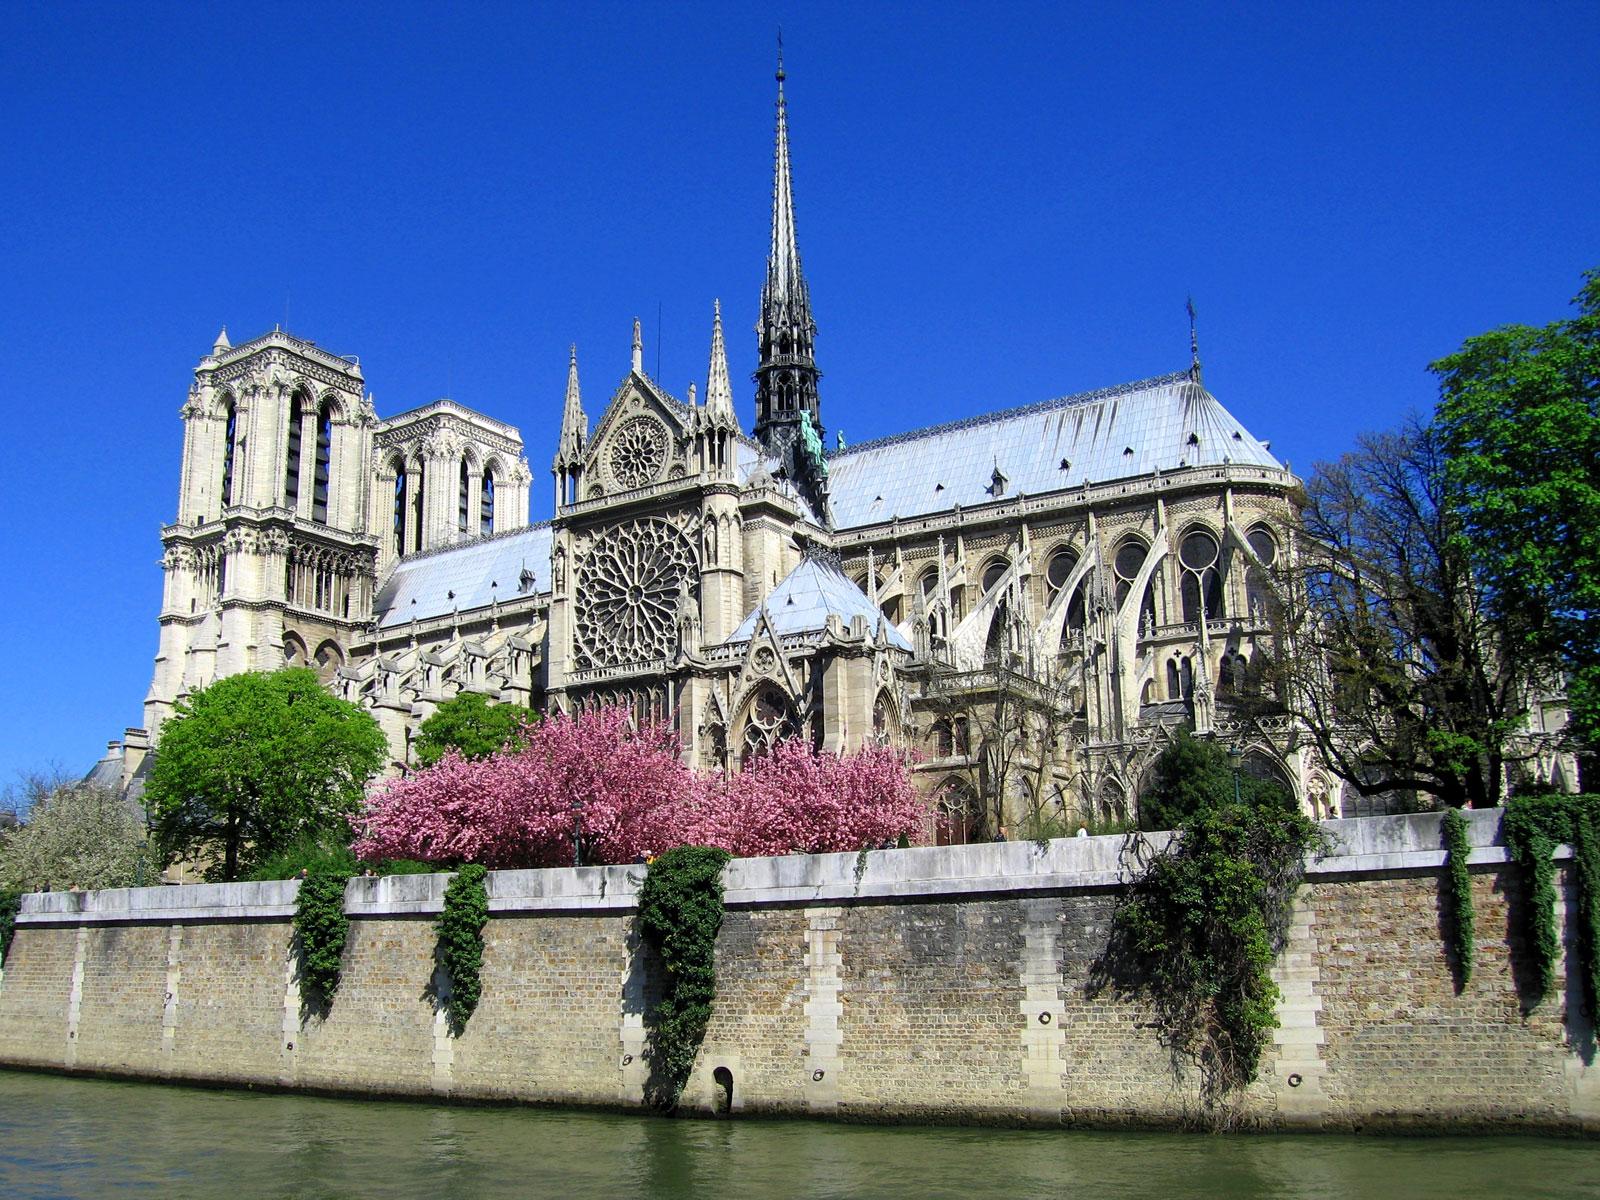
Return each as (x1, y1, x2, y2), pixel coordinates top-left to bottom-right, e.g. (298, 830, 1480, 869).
(0, 811, 1600, 1134)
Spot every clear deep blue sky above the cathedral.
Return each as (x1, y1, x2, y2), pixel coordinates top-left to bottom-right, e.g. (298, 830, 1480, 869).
(0, 0, 1600, 779)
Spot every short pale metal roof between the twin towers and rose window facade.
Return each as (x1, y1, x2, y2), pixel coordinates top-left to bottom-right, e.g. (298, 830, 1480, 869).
(374, 522, 550, 629)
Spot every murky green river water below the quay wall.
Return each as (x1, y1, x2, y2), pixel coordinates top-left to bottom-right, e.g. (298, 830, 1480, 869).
(0, 1070, 1600, 1200)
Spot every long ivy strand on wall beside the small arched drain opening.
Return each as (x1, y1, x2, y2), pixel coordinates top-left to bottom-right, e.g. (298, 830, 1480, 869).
(638, 846, 728, 1109)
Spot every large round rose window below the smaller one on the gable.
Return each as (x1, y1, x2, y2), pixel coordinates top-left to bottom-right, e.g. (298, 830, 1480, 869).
(578, 517, 698, 667)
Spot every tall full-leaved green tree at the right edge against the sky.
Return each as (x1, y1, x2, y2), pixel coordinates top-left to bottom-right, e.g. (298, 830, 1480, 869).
(1432, 269, 1600, 754)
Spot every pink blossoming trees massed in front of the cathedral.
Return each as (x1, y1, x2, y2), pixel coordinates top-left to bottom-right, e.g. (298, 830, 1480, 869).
(355, 707, 928, 869)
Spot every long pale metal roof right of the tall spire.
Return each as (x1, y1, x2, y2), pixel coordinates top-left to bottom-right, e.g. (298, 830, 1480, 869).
(827, 371, 1283, 528)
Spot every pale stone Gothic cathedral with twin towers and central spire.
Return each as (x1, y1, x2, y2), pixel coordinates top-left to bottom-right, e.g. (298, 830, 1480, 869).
(123, 67, 1338, 840)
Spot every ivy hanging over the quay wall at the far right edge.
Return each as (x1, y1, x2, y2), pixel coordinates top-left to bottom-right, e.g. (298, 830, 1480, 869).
(1504, 795, 1600, 1014)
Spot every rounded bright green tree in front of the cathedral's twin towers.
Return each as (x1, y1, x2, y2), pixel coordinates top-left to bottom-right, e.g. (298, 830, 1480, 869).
(144, 669, 387, 880)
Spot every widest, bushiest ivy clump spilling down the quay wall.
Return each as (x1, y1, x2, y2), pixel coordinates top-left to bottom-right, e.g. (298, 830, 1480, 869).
(1096, 803, 1326, 1120)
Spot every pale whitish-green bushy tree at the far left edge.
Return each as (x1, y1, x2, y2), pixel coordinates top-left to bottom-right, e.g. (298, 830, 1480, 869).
(0, 784, 155, 890)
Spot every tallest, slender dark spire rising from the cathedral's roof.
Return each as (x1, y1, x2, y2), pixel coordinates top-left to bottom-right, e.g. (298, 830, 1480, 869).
(754, 35, 827, 502)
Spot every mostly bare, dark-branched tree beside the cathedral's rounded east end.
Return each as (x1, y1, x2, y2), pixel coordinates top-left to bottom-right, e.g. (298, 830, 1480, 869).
(1262, 419, 1526, 806)
